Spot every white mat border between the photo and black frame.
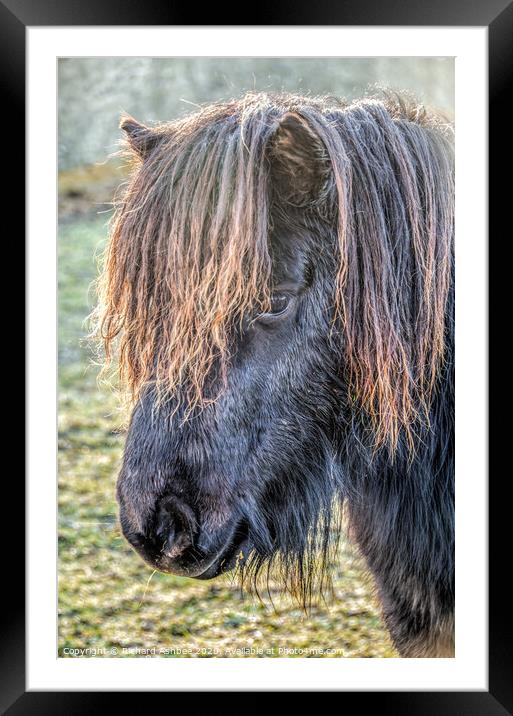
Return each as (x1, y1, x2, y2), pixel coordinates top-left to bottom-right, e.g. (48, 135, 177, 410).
(27, 27, 488, 690)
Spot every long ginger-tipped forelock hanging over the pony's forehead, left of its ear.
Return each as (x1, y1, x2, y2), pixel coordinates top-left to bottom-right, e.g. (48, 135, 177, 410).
(94, 96, 282, 407)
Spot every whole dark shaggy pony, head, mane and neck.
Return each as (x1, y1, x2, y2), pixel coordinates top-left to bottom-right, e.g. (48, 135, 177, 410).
(96, 93, 454, 657)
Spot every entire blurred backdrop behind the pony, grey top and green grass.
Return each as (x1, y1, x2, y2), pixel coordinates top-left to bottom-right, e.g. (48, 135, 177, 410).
(58, 57, 454, 657)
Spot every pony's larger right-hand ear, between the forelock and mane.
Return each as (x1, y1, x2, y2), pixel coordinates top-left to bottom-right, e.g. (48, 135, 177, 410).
(270, 112, 331, 207)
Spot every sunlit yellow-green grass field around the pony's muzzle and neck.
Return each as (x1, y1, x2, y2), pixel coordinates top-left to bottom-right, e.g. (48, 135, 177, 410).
(58, 215, 396, 657)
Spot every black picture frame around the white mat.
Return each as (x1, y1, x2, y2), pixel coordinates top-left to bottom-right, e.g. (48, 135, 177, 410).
(10, 0, 506, 716)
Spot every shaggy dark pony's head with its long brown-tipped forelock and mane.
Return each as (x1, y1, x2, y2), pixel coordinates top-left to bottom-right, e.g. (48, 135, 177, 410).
(94, 94, 453, 604)
